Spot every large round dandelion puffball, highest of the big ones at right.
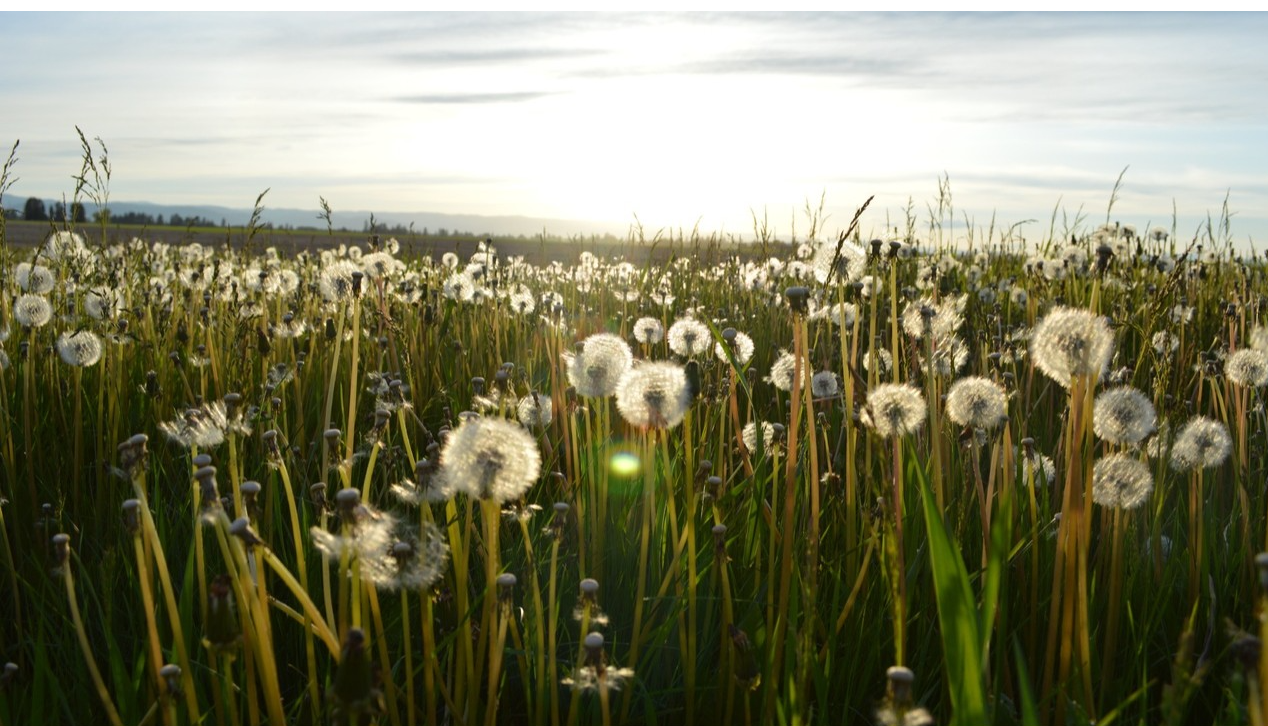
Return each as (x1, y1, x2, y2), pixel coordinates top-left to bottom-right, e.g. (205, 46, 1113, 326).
(1031, 308, 1113, 388)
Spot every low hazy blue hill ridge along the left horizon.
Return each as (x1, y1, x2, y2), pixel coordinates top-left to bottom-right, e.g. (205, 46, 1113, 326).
(5, 198, 628, 238)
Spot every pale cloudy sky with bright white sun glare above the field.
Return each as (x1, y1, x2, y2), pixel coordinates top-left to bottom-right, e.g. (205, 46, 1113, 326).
(0, 11, 1268, 247)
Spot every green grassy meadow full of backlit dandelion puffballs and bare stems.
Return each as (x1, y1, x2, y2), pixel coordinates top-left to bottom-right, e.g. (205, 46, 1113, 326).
(0, 164, 1268, 726)
